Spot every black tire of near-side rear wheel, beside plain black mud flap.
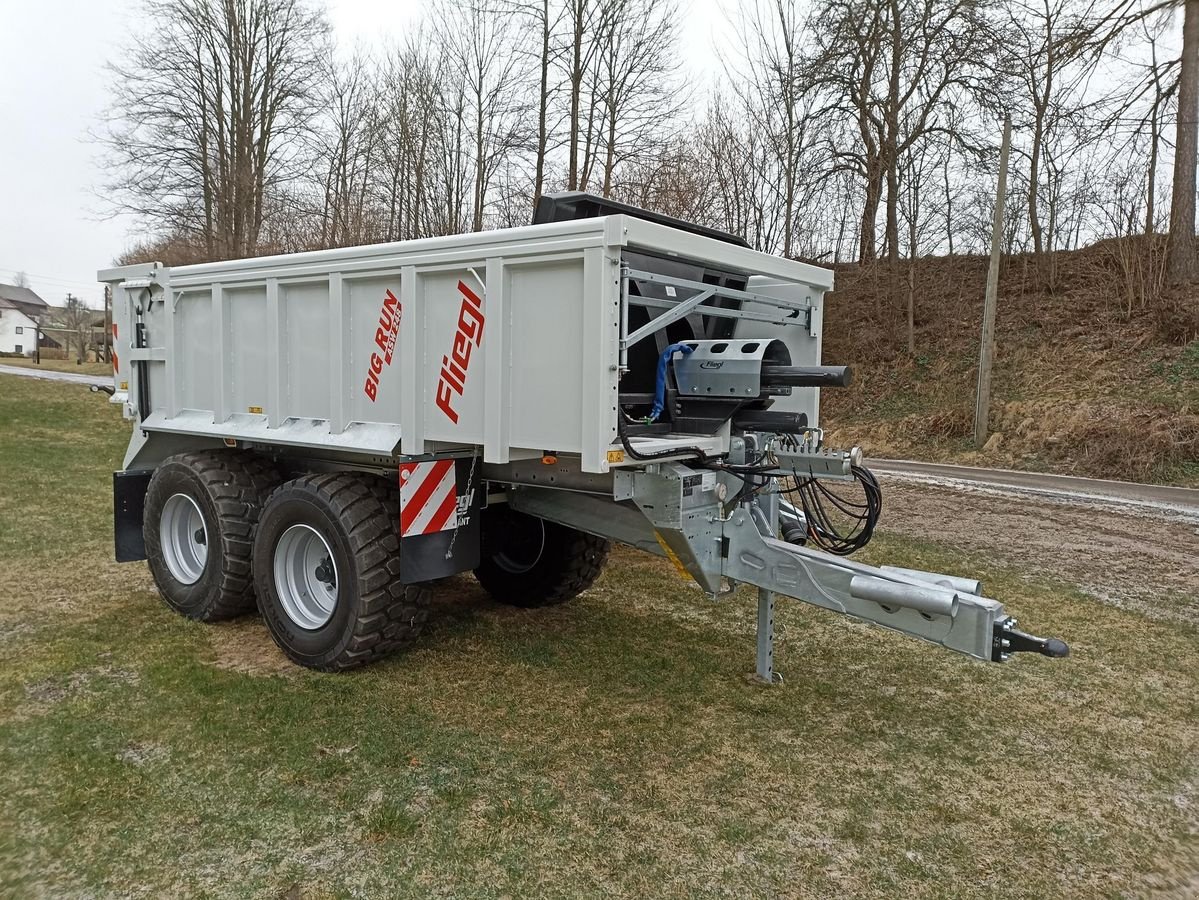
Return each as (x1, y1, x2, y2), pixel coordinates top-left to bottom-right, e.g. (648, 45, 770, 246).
(141, 449, 279, 622)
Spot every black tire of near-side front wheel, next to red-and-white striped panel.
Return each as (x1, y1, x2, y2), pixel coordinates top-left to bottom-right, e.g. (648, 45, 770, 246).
(254, 472, 432, 672)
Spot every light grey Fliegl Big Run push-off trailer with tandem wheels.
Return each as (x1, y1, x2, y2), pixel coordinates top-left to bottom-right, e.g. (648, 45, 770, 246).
(100, 193, 1068, 681)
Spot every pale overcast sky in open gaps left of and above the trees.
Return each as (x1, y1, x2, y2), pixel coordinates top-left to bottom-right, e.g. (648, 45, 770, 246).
(0, 0, 731, 306)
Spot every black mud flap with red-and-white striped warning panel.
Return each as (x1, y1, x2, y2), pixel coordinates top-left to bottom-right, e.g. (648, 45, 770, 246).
(399, 457, 483, 584)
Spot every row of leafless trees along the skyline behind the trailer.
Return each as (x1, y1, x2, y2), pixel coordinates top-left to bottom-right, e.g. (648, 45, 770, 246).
(104, 0, 1199, 330)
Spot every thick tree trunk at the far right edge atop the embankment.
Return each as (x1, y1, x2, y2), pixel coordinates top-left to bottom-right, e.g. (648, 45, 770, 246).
(1165, 0, 1199, 284)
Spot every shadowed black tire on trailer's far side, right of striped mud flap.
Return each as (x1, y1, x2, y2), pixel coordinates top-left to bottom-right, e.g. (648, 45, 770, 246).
(475, 503, 611, 609)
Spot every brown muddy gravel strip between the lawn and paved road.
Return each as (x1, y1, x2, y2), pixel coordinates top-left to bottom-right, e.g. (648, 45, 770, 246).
(879, 472, 1199, 624)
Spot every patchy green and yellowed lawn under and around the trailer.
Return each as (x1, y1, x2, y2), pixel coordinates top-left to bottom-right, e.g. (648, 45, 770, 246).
(0, 376, 1199, 898)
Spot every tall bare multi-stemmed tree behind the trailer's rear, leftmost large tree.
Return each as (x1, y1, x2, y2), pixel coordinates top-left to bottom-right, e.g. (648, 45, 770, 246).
(102, 0, 326, 258)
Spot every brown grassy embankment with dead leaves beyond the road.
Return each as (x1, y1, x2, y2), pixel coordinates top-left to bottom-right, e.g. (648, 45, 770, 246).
(823, 241, 1199, 487)
